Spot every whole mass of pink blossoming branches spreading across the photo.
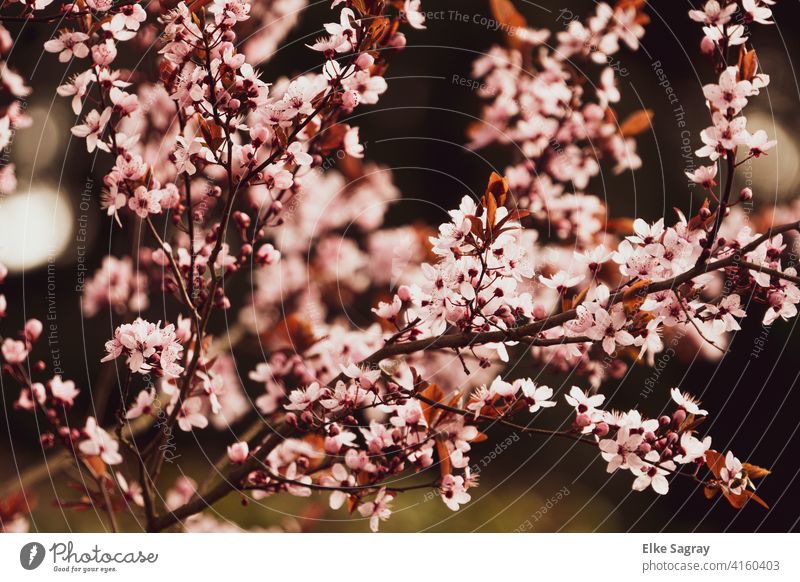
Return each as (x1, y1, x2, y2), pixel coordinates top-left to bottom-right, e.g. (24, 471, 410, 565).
(0, 0, 800, 531)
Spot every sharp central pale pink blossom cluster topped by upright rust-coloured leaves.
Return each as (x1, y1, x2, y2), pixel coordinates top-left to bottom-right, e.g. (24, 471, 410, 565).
(374, 175, 534, 360)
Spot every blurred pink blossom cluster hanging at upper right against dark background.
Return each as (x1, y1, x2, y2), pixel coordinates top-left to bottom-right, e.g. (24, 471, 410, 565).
(472, 2, 649, 243)
